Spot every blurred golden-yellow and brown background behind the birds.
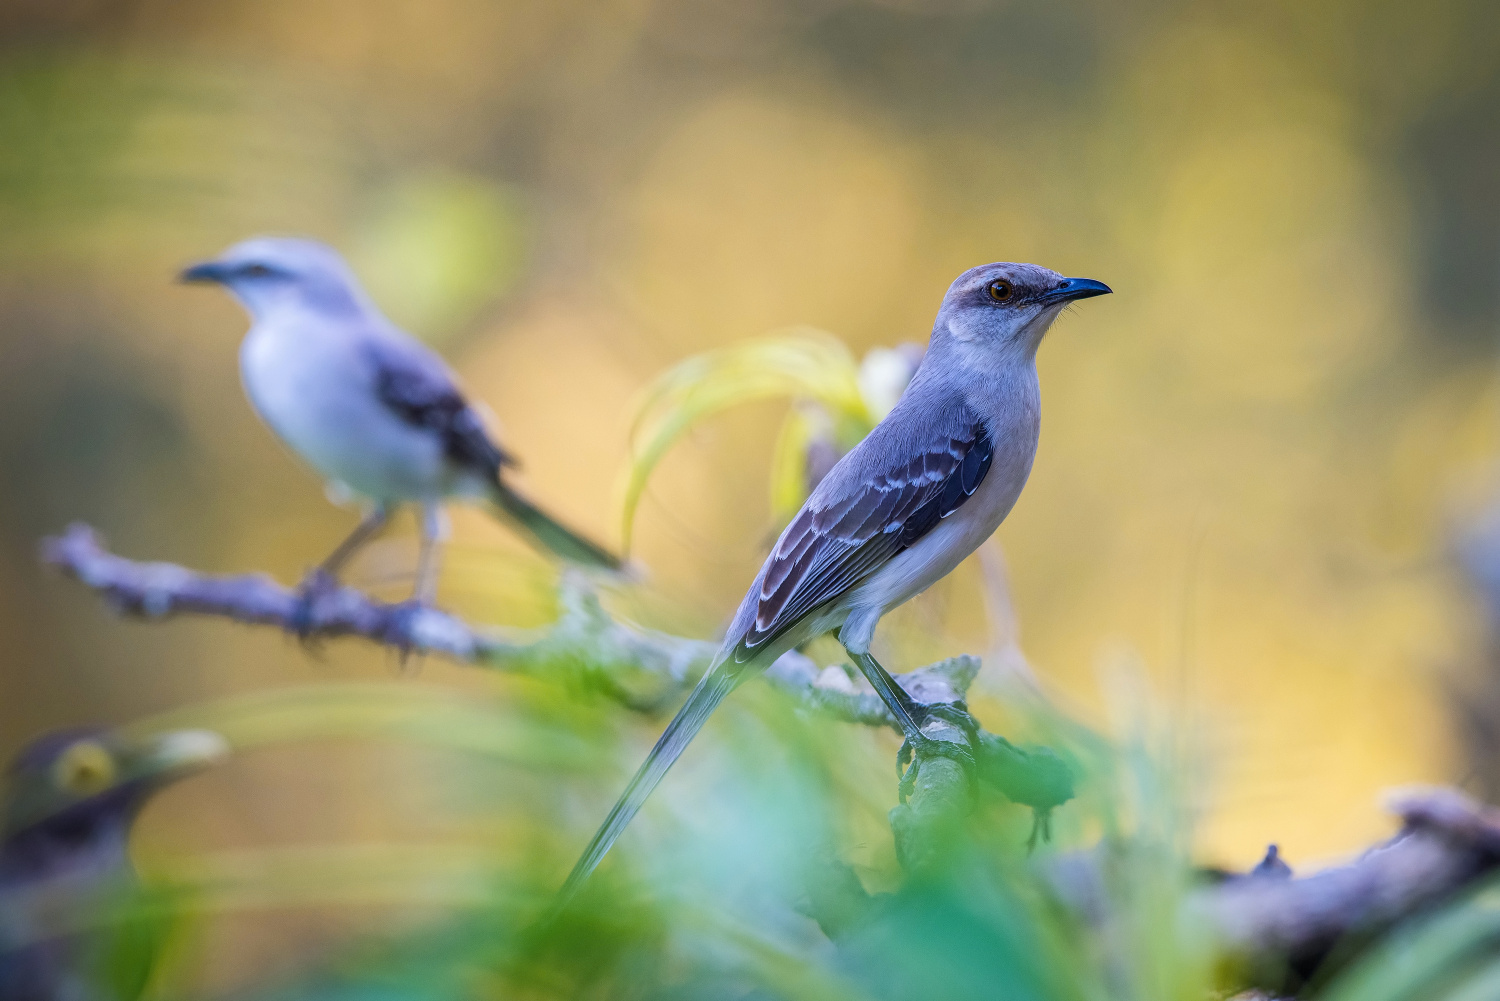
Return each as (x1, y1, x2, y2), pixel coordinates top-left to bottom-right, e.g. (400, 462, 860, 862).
(0, 0, 1500, 980)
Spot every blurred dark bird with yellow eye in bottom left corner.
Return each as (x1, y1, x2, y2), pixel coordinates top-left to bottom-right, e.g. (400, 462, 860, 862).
(0, 729, 230, 1001)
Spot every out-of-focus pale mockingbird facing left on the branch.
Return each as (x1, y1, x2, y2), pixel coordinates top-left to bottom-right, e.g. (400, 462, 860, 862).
(182, 237, 620, 603)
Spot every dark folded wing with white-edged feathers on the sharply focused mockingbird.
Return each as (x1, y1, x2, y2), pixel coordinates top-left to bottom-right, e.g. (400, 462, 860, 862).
(735, 414, 995, 663)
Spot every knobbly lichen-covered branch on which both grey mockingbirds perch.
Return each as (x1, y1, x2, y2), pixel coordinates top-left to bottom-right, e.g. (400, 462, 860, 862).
(42, 525, 1073, 858)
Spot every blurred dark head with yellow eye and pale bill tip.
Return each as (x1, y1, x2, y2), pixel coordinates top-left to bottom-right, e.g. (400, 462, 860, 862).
(0, 729, 230, 882)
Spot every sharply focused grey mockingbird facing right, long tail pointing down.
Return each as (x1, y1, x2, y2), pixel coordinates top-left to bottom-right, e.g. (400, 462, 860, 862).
(563, 264, 1110, 899)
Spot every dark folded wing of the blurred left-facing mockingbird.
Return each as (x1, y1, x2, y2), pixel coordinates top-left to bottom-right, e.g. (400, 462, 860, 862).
(369, 341, 516, 479)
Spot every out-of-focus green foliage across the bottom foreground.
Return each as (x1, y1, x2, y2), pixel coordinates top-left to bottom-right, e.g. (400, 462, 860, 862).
(70, 672, 1214, 1001)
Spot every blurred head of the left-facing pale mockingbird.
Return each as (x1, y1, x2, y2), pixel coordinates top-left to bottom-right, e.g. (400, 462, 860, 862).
(180, 237, 374, 320)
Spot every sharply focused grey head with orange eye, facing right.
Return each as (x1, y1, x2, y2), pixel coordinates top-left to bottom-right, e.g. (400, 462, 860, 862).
(933, 264, 1113, 357)
